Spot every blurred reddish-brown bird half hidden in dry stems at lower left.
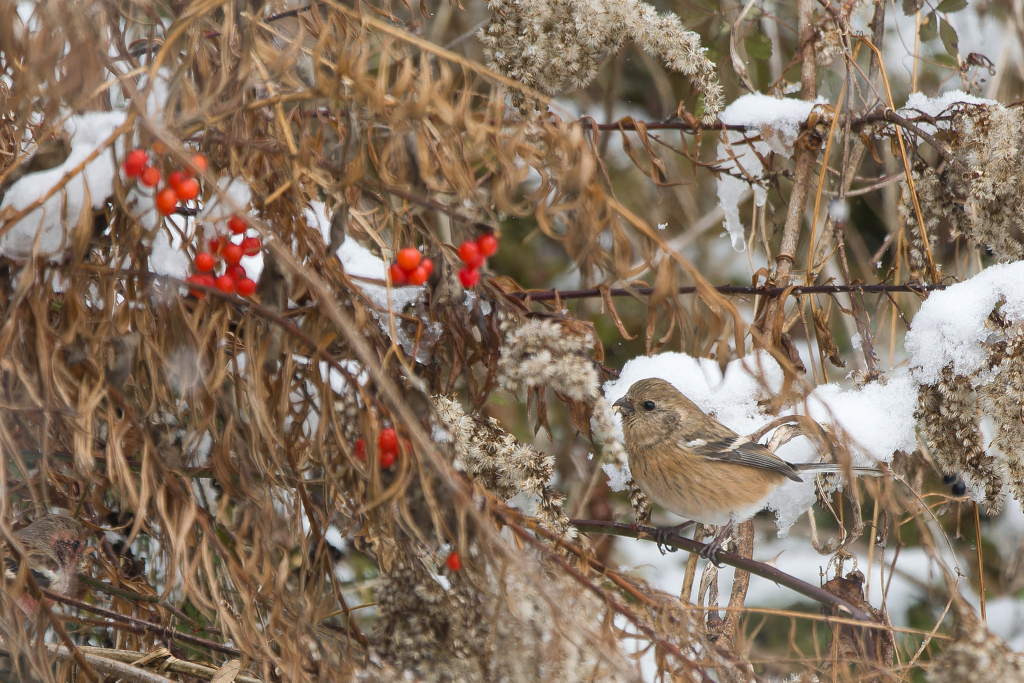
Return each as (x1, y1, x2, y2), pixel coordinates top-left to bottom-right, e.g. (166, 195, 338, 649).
(4, 514, 86, 613)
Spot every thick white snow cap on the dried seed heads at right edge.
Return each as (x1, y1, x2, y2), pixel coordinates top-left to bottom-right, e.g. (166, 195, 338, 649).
(904, 261, 1024, 384)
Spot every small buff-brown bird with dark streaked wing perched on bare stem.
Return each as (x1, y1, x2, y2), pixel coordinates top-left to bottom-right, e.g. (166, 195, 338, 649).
(612, 379, 882, 564)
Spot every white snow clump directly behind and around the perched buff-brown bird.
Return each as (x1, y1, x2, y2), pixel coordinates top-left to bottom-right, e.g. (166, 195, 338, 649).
(604, 351, 918, 537)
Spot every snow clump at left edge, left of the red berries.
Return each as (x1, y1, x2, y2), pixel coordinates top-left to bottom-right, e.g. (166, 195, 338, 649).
(0, 112, 125, 260)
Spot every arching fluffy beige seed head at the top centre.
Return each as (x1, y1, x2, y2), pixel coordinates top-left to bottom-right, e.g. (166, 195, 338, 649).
(480, 0, 722, 124)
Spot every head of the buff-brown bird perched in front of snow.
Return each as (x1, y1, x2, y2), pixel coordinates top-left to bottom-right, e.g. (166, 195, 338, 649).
(612, 378, 700, 449)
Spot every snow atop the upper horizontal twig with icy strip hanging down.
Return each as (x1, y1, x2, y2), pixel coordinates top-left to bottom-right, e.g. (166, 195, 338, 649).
(718, 92, 827, 252)
